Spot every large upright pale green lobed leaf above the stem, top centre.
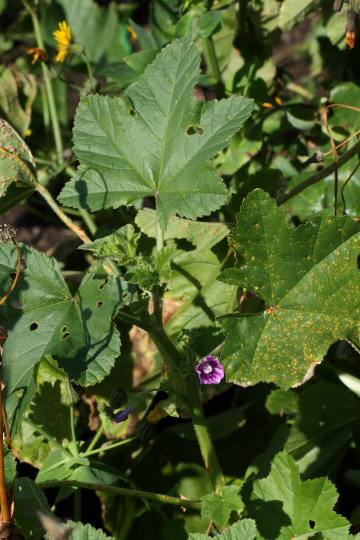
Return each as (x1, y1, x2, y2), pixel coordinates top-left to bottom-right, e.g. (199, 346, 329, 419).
(59, 39, 252, 228)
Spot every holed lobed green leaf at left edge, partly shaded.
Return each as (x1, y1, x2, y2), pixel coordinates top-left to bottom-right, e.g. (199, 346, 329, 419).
(0, 244, 135, 432)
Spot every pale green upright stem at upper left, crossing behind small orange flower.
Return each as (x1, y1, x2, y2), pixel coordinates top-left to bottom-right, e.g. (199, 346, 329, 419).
(23, 0, 64, 163)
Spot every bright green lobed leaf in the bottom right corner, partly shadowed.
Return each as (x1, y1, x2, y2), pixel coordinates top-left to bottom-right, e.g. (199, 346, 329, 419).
(246, 452, 350, 540)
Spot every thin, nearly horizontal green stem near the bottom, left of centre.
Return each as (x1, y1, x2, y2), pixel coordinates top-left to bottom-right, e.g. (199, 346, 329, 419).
(37, 480, 202, 510)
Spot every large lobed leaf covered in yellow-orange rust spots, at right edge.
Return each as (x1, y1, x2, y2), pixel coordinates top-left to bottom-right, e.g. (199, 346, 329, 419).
(220, 190, 360, 388)
